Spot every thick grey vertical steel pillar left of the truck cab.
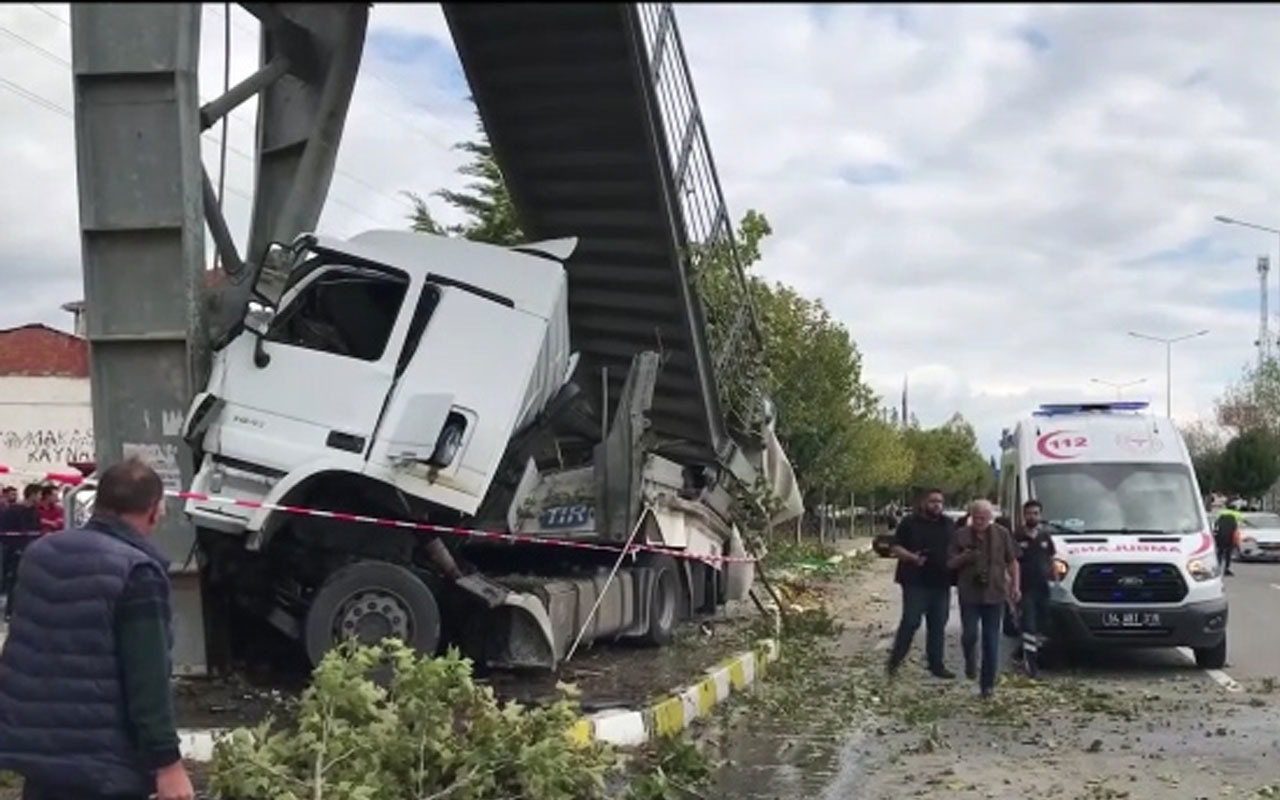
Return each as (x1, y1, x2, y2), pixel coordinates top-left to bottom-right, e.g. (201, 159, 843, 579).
(72, 3, 206, 675)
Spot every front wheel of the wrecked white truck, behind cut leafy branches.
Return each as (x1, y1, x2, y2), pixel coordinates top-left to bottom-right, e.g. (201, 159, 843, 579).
(303, 561, 440, 666)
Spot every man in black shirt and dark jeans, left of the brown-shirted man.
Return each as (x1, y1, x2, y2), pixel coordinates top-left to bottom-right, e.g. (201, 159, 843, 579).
(888, 489, 955, 678)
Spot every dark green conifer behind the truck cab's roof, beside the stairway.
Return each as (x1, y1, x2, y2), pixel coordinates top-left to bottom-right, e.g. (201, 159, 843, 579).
(403, 115, 525, 246)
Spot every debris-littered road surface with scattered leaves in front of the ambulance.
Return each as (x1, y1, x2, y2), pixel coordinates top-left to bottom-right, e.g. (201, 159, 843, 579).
(701, 561, 1280, 800)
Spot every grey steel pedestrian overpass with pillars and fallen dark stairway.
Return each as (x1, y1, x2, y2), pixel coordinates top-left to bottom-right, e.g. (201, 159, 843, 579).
(72, 3, 760, 675)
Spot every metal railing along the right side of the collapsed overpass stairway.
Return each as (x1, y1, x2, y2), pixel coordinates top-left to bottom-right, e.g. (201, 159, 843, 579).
(637, 3, 764, 431)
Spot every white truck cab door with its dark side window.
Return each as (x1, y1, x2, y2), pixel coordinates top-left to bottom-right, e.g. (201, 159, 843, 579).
(218, 262, 411, 471)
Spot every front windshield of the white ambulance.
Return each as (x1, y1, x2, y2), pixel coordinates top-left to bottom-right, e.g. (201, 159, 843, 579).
(1027, 463, 1203, 534)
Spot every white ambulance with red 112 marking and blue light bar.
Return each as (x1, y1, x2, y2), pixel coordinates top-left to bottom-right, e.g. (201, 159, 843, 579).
(1000, 402, 1228, 669)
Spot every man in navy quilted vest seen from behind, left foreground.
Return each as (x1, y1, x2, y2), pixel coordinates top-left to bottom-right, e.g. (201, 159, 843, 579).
(0, 458, 195, 800)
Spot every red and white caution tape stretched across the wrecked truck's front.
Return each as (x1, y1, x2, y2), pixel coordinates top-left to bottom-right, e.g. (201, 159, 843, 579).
(0, 465, 756, 564)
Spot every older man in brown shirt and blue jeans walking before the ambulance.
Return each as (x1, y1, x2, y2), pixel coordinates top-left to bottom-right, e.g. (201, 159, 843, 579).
(947, 500, 1021, 698)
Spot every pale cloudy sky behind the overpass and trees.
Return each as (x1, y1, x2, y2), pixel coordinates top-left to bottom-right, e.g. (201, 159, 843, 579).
(0, 4, 1280, 452)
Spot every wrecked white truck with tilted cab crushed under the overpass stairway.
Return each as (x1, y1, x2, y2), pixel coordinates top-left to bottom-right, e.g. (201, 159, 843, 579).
(183, 230, 803, 668)
